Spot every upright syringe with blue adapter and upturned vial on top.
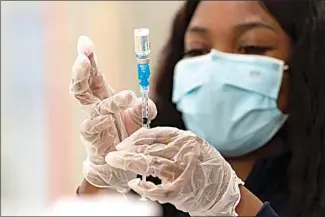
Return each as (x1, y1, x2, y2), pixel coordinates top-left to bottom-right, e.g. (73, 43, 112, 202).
(134, 28, 150, 200)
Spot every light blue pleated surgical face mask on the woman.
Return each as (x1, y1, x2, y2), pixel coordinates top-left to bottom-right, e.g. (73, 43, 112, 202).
(173, 50, 287, 157)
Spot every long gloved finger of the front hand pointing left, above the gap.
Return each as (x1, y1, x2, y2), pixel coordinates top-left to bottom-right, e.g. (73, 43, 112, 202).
(105, 151, 185, 181)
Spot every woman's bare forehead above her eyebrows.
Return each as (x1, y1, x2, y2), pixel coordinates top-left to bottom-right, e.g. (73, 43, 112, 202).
(189, 1, 280, 32)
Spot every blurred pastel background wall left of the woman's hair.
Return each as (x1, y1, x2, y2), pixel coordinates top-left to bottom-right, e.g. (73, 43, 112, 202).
(1, 1, 182, 215)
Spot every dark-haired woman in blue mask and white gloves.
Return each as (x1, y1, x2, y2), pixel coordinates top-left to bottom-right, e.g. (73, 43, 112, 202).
(71, 0, 325, 216)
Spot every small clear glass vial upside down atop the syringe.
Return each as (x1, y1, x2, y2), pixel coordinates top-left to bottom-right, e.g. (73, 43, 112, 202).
(134, 28, 150, 56)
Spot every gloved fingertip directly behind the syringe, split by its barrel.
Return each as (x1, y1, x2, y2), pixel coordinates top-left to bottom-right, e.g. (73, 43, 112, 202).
(123, 98, 157, 135)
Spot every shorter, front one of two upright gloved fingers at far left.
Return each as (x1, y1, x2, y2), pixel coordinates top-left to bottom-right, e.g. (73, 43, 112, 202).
(69, 54, 97, 105)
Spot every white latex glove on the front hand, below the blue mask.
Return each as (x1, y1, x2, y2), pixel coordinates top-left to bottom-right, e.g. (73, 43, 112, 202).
(105, 127, 243, 216)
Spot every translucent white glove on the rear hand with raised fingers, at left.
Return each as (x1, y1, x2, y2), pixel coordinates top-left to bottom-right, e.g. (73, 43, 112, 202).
(69, 36, 157, 191)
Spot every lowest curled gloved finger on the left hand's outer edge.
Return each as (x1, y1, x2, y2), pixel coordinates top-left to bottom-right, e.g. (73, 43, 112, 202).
(80, 115, 114, 137)
